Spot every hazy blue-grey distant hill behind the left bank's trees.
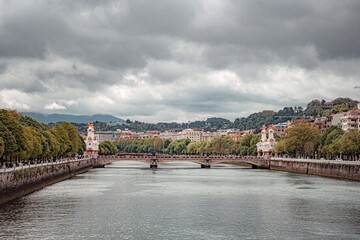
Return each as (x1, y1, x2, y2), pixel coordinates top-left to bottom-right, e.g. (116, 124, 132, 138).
(22, 112, 125, 123)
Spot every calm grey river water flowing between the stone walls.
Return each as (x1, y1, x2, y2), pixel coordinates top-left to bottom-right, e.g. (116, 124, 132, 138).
(0, 161, 360, 240)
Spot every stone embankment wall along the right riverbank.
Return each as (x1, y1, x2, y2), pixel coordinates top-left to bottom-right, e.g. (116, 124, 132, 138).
(270, 159, 360, 181)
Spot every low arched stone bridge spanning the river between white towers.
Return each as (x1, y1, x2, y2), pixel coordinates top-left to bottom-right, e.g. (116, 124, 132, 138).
(98, 153, 270, 169)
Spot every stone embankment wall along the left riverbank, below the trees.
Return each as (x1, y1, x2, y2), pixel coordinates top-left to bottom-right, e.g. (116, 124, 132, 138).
(0, 158, 95, 204)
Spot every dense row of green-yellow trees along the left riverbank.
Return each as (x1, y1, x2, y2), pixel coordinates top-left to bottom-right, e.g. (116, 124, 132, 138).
(0, 109, 84, 161)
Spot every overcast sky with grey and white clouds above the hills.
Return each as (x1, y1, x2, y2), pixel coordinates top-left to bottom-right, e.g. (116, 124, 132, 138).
(0, 0, 360, 122)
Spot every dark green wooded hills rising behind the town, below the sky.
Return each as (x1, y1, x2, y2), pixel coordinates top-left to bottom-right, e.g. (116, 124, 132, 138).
(34, 98, 359, 133)
